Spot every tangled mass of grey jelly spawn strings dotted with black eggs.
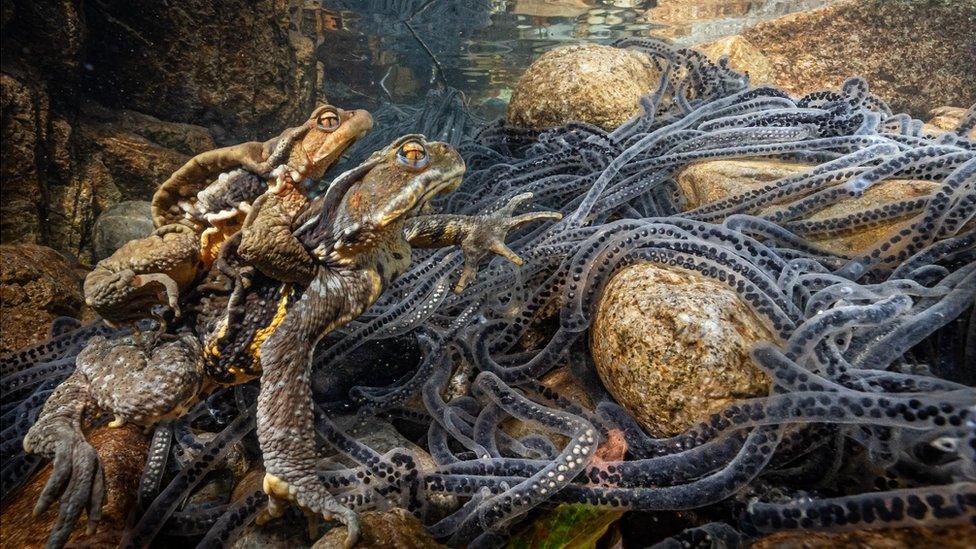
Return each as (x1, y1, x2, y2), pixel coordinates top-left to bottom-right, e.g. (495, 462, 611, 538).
(2, 39, 976, 547)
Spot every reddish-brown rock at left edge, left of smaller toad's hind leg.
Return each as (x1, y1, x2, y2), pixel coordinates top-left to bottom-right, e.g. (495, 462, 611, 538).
(0, 244, 85, 353)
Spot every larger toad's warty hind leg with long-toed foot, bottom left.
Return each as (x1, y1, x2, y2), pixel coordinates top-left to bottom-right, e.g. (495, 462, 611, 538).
(24, 333, 203, 548)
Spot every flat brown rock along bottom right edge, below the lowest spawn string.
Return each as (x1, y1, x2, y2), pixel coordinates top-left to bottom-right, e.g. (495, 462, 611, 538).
(751, 525, 976, 549)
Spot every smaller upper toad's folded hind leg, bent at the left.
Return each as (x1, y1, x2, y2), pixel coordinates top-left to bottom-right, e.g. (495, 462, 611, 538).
(85, 224, 201, 324)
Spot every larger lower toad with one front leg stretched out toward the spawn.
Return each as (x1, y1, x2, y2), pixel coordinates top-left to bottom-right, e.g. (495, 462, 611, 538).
(24, 135, 561, 546)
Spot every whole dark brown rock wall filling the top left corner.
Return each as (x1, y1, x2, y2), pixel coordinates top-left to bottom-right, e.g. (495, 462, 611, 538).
(0, 0, 317, 262)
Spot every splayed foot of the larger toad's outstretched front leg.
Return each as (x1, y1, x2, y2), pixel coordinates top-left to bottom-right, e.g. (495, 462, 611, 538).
(454, 193, 563, 293)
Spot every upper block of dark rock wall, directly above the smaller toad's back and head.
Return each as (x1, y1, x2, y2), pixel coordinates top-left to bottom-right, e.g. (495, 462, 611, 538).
(85, 0, 315, 140)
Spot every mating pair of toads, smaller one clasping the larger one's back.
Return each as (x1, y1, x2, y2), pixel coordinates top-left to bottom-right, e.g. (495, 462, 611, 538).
(24, 106, 561, 546)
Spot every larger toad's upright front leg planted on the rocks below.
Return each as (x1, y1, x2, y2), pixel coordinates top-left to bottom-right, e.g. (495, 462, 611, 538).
(257, 267, 378, 547)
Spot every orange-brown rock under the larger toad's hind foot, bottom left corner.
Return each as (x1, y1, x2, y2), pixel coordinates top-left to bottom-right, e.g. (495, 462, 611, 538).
(0, 425, 149, 547)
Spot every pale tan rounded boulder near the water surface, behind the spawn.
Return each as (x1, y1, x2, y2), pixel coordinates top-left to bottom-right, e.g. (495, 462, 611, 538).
(508, 44, 658, 130)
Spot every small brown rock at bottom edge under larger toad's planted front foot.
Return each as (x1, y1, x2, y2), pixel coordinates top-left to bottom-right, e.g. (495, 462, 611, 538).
(312, 507, 444, 549)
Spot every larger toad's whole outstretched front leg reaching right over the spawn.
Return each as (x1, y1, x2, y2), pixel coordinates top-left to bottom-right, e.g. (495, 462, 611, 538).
(406, 193, 562, 293)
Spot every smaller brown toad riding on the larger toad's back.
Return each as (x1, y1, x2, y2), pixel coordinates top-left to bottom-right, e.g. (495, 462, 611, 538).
(84, 105, 373, 325)
